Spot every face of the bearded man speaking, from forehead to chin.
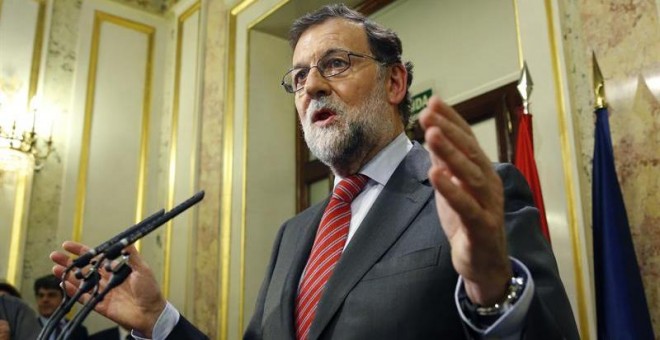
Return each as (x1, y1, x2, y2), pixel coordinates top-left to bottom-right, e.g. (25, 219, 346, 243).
(293, 19, 400, 172)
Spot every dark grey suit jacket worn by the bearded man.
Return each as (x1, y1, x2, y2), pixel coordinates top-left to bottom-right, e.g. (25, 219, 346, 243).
(244, 144, 578, 340)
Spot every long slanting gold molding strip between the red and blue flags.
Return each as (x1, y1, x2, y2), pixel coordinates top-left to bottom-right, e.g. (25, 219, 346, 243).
(545, 0, 591, 340)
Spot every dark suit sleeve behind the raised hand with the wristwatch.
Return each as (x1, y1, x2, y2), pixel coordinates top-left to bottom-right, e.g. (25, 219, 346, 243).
(496, 164, 579, 339)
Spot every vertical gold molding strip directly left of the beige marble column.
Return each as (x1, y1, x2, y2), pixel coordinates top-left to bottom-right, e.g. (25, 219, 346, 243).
(162, 1, 201, 301)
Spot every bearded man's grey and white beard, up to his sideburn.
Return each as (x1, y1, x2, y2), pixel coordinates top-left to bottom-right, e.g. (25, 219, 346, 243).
(302, 85, 394, 173)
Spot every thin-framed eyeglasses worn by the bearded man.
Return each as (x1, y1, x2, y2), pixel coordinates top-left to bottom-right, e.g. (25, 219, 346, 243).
(282, 50, 381, 93)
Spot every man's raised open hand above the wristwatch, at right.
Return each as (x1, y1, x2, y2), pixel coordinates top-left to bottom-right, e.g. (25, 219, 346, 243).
(419, 96, 512, 306)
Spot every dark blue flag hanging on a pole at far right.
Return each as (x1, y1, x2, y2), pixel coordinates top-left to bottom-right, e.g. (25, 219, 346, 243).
(592, 108, 654, 339)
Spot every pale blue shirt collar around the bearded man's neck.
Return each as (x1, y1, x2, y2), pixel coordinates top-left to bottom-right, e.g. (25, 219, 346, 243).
(335, 132, 413, 186)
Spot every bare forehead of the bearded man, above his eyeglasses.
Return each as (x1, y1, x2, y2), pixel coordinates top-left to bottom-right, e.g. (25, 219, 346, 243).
(293, 18, 369, 65)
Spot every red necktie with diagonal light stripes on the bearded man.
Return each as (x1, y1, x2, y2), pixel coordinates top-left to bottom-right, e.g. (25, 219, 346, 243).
(296, 175, 369, 340)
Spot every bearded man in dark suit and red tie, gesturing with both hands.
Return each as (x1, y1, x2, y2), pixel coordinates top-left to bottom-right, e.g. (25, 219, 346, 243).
(52, 5, 578, 339)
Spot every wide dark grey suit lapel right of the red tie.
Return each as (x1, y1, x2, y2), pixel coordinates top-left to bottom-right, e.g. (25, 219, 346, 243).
(303, 144, 433, 339)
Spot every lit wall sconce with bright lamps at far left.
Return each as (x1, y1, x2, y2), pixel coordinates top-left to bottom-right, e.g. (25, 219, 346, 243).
(0, 93, 54, 171)
